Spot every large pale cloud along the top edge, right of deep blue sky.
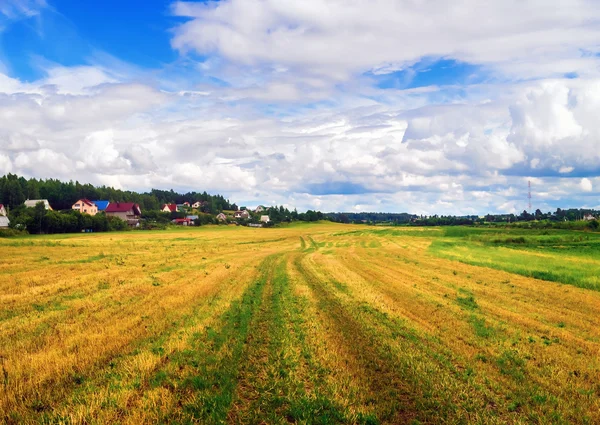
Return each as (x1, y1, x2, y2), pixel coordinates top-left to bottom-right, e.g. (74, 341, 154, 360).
(172, 0, 600, 80)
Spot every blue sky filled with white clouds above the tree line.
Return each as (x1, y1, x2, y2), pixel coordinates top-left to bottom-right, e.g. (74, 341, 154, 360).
(0, 0, 600, 215)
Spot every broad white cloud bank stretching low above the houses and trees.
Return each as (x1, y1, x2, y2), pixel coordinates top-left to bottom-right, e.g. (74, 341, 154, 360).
(0, 65, 600, 214)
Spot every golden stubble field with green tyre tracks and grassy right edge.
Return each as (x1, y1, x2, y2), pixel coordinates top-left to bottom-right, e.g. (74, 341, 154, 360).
(0, 223, 600, 424)
